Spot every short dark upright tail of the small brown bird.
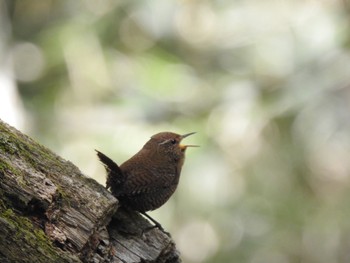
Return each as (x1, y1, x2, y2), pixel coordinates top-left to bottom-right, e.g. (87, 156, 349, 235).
(95, 150, 125, 193)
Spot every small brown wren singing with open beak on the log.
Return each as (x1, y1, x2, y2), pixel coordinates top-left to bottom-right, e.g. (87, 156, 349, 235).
(97, 132, 198, 230)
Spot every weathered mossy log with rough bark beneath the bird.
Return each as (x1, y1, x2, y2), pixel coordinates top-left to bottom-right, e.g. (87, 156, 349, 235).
(0, 120, 181, 263)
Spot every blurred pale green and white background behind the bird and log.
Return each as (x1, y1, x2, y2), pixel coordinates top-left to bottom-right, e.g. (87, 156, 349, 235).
(0, 0, 350, 263)
